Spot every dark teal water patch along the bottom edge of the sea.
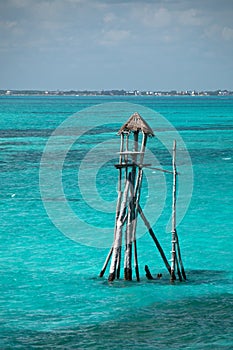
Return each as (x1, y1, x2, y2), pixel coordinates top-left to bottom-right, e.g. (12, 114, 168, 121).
(1, 294, 233, 350)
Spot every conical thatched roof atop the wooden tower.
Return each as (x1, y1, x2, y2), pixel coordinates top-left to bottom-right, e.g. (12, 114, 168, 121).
(118, 112, 154, 136)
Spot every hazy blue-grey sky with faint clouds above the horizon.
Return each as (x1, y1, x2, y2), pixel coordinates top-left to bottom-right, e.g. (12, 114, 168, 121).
(0, 0, 233, 91)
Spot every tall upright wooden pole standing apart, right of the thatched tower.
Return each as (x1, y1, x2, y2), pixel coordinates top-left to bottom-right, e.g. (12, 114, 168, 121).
(171, 140, 177, 282)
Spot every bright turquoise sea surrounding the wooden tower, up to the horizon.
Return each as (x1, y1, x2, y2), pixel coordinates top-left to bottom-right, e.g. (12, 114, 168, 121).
(0, 96, 233, 350)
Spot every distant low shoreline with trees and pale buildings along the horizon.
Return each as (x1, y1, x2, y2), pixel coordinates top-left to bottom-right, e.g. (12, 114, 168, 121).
(0, 90, 233, 96)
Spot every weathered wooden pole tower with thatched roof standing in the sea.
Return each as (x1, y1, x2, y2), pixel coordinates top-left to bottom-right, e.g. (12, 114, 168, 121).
(100, 112, 186, 281)
